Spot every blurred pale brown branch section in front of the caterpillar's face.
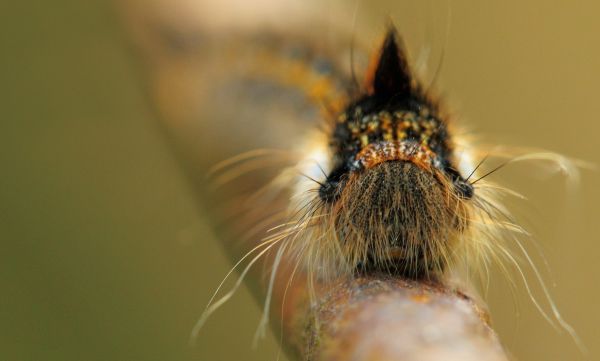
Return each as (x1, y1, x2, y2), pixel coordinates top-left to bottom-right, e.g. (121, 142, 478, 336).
(284, 274, 507, 361)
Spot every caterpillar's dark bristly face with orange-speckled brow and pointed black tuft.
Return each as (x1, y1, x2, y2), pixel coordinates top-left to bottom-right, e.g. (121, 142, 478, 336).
(319, 29, 474, 277)
